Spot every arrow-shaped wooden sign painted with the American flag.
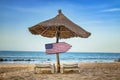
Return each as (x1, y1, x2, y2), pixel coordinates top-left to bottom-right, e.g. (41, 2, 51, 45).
(45, 42, 72, 54)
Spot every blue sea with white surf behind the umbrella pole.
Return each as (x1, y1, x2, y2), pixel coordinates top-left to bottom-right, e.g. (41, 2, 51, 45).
(0, 51, 120, 64)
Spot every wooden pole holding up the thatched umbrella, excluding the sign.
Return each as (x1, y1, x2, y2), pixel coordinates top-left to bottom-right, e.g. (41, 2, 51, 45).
(56, 27, 60, 73)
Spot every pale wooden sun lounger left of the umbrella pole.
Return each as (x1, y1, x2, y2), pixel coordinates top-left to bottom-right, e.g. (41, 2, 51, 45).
(34, 63, 55, 73)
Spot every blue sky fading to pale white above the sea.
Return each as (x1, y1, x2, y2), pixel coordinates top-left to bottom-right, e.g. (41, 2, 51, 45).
(0, 0, 120, 52)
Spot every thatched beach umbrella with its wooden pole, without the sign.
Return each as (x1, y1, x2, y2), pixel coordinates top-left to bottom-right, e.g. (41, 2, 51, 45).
(29, 10, 91, 72)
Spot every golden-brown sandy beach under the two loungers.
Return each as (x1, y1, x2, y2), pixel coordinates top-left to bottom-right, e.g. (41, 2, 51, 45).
(0, 62, 120, 80)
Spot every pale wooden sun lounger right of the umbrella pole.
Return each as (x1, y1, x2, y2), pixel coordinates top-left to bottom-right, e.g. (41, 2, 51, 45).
(61, 63, 80, 73)
